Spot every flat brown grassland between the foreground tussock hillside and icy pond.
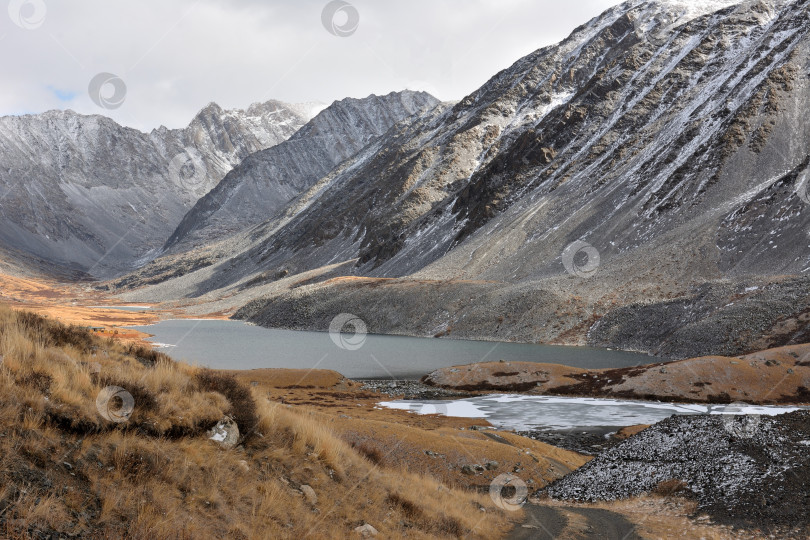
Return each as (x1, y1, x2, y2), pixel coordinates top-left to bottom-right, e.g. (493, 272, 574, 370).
(222, 369, 589, 489)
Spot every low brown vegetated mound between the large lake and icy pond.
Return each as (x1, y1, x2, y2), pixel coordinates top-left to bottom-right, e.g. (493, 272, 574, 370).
(423, 345, 810, 404)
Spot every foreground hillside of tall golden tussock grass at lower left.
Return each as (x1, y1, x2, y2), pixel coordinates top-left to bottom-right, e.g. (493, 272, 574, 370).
(0, 306, 517, 539)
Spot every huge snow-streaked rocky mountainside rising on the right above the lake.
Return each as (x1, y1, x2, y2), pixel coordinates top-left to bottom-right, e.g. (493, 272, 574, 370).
(118, 0, 810, 356)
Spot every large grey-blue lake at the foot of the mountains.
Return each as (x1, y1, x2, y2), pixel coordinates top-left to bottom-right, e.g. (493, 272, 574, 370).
(132, 319, 662, 379)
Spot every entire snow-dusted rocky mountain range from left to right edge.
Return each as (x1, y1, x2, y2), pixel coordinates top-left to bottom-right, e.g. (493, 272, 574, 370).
(0, 0, 810, 357)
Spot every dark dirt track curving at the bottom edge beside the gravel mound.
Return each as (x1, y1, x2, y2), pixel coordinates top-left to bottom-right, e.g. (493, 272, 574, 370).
(507, 504, 640, 540)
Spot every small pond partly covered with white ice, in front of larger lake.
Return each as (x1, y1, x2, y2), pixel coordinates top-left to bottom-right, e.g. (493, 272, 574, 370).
(379, 394, 802, 431)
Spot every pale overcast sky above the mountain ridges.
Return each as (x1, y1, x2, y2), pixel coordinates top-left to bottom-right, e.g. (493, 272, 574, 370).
(0, 0, 617, 130)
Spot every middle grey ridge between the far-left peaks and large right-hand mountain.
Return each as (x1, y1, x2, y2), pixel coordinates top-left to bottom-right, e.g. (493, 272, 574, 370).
(166, 90, 438, 251)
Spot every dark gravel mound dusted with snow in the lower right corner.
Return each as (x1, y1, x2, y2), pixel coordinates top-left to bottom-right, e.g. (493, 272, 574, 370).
(538, 411, 810, 538)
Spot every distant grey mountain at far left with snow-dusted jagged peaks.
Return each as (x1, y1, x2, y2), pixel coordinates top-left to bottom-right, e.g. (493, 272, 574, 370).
(0, 101, 313, 277)
